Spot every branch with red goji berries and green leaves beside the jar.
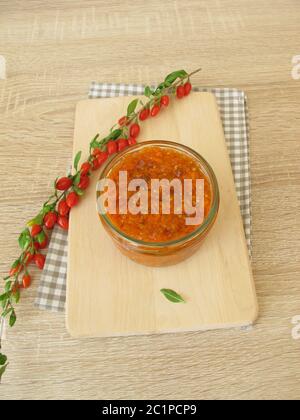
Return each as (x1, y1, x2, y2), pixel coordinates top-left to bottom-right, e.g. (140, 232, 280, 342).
(0, 69, 201, 381)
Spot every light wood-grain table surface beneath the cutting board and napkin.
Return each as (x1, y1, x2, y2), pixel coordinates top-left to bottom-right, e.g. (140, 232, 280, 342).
(0, 0, 300, 399)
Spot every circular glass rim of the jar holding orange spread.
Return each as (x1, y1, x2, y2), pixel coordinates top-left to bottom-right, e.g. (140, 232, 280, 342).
(96, 140, 220, 248)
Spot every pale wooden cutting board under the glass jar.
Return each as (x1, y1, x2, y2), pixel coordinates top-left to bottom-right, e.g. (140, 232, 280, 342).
(66, 93, 258, 337)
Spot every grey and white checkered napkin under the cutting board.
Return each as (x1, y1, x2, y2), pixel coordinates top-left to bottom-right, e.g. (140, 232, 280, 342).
(35, 82, 251, 311)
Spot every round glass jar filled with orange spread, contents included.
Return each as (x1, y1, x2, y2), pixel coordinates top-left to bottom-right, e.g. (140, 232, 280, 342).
(97, 141, 219, 266)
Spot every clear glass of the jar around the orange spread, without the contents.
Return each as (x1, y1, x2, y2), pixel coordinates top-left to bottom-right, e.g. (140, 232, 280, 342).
(97, 140, 219, 267)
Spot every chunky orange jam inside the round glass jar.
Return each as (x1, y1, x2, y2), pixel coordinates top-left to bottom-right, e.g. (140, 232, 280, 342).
(107, 146, 212, 243)
